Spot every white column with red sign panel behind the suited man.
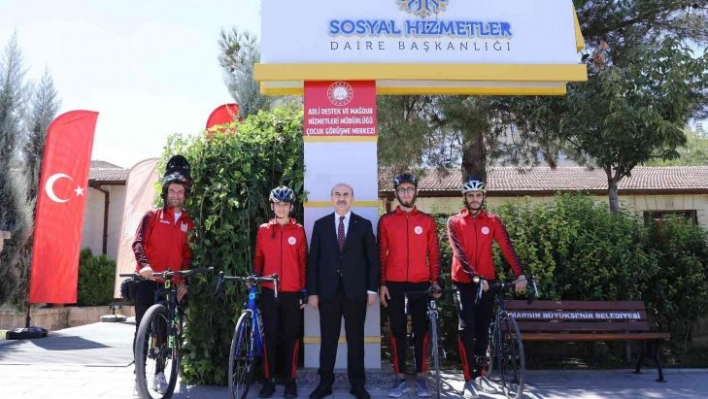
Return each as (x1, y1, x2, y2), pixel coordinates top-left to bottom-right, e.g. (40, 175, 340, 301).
(303, 81, 381, 369)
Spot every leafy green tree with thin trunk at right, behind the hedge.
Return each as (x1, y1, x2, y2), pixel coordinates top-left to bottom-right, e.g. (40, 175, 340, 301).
(558, 38, 708, 213)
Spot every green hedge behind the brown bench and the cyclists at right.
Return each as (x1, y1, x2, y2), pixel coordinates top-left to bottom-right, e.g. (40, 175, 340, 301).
(428, 194, 708, 357)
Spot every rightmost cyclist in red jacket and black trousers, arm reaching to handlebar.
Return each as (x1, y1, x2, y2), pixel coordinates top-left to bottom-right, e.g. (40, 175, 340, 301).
(447, 177, 526, 398)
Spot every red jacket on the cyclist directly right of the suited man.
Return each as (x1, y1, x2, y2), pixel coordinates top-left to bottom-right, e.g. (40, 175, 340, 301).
(378, 206, 440, 285)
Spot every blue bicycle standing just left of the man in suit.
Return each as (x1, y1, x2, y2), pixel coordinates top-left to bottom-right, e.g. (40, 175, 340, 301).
(216, 272, 278, 399)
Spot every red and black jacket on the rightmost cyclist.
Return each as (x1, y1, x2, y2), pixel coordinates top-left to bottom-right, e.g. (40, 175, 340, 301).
(447, 208, 524, 283)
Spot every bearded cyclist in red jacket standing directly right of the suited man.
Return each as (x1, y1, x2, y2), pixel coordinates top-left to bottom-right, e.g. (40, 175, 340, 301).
(378, 173, 440, 398)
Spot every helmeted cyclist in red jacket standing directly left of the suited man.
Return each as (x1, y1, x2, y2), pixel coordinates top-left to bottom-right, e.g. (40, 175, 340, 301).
(253, 186, 307, 398)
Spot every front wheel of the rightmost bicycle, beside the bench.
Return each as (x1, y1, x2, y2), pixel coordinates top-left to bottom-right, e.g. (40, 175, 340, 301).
(497, 314, 526, 399)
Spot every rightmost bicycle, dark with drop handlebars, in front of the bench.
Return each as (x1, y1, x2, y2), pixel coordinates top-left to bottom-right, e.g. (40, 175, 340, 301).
(473, 276, 538, 399)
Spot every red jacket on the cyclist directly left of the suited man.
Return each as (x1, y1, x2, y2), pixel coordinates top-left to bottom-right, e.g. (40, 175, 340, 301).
(253, 218, 307, 292)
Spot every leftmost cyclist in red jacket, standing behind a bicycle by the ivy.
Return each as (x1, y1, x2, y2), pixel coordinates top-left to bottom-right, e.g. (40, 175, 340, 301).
(133, 155, 194, 397)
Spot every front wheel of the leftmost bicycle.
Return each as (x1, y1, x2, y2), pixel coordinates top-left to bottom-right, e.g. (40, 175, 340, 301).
(134, 304, 179, 399)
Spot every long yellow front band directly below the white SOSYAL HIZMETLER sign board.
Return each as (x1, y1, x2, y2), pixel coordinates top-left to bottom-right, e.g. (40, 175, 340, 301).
(254, 63, 588, 82)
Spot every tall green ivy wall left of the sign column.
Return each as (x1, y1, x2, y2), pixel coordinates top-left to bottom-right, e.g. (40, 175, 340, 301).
(161, 107, 305, 385)
